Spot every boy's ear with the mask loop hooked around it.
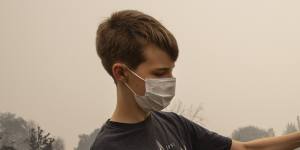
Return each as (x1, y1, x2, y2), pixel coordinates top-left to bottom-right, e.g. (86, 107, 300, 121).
(112, 63, 128, 81)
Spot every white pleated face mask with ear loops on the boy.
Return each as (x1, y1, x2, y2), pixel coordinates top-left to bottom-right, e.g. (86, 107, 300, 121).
(124, 68, 176, 112)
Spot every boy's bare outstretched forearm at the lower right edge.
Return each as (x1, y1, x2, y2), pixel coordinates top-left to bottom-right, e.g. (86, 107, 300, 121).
(244, 132, 300, 150)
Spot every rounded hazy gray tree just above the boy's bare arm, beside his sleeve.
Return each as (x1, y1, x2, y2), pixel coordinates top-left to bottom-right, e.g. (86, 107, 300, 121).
(232, 126, 275, 142)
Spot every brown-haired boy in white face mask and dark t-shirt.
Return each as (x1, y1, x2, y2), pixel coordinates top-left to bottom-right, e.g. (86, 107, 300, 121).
(91, 10, 300, 150)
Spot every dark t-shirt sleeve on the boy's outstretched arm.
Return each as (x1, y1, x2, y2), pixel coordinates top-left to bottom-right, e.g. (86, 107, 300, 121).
(171, 112, 232, 150)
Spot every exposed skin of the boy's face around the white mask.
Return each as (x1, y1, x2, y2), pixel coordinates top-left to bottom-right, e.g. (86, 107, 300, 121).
(127, 45, 175, 95)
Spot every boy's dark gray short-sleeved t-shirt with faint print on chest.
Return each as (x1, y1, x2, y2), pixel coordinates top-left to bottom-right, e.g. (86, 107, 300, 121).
(90, 111, 232, 150)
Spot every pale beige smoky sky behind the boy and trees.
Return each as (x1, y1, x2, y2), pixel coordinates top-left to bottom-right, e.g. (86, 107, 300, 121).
(0, 0, 300, 150)
